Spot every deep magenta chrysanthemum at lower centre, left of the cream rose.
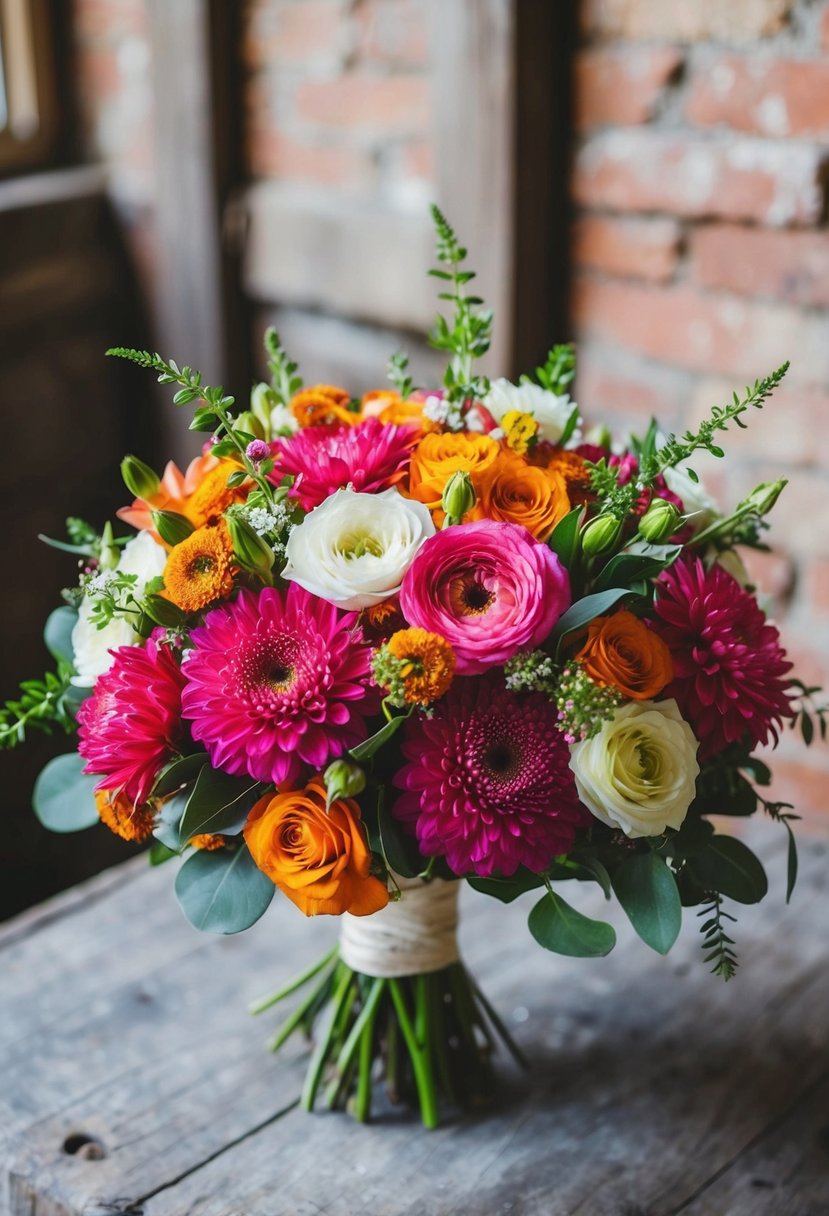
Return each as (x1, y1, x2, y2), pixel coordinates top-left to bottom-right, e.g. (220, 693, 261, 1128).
(394, 675, 590, 874)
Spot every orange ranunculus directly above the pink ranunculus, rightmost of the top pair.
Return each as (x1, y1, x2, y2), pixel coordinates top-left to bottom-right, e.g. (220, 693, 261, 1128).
(474, 451, 570, 540)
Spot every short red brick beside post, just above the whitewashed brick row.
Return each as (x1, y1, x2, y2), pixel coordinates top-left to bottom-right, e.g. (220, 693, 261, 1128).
(575, 46, 684, 128)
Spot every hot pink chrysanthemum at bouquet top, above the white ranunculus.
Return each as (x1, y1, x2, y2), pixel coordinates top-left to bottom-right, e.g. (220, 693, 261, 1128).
(273, 418, 419, 511)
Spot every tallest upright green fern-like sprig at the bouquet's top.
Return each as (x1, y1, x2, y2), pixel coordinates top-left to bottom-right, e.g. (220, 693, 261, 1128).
(429, 204, 492, 406)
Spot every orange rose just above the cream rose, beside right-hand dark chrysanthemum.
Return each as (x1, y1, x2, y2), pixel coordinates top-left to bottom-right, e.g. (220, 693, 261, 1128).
(576, 610, 673, 700)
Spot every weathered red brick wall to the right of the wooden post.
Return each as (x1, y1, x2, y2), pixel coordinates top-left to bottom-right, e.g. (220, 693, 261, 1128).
(571, 0, 829, 812)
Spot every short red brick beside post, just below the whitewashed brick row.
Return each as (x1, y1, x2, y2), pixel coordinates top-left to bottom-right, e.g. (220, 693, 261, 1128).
(573, 215, 681, 282)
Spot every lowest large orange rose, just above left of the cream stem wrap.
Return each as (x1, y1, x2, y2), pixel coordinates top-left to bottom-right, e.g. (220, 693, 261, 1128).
(244, 777, 389, 916)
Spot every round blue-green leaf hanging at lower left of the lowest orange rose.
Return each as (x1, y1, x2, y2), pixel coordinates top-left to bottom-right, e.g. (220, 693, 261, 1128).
(175, 845, 275, 933)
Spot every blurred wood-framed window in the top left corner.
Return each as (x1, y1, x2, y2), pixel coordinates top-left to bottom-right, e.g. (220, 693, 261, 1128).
(0, 0, 60, 174)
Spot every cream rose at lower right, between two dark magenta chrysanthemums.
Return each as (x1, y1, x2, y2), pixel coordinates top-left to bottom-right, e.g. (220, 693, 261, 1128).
(570, 700, 699, 837)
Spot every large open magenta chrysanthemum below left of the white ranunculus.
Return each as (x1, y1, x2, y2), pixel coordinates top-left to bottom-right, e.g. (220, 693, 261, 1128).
(181, 584, 377, 782)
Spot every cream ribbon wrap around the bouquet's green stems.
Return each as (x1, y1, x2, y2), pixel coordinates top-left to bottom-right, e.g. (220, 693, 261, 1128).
(339, 878, 461, 979)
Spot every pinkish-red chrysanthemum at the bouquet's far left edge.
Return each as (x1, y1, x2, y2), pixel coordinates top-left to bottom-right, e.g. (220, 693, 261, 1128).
(78, 637, 184, 805)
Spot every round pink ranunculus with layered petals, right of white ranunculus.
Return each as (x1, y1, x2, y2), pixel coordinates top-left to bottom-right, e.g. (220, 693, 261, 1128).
(400, 519, 570, 675)
